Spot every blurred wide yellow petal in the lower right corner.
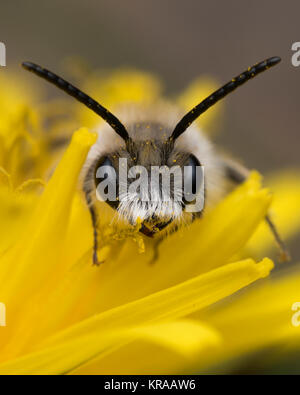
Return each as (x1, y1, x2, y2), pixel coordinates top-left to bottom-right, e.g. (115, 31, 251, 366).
(193, 268, 300, 372)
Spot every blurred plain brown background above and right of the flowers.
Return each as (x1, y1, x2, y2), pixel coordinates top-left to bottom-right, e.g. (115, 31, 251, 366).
(0, 0, 300, 262)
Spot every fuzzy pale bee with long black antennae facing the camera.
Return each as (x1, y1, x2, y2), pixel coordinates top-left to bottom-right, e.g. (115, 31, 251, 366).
(22, 57, 288, 264)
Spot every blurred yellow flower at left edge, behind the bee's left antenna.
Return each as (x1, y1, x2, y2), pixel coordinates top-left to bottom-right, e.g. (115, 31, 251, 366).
(0, 72, 78, 188)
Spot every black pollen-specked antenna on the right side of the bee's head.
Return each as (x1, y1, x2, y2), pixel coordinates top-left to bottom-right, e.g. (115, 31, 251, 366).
(170, 56, 281, 141)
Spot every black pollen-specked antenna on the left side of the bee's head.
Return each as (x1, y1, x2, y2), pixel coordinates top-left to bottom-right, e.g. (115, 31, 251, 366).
(22, 62, 130, 142)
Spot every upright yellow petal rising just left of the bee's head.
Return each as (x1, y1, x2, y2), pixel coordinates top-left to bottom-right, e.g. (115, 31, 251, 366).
(2, 129, 96, 297)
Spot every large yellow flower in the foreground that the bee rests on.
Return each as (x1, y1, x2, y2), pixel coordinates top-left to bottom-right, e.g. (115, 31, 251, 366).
(0, 69, 300, 374)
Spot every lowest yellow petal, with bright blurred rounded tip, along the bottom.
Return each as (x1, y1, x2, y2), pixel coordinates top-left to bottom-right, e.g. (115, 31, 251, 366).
(0, 321, 220, 375)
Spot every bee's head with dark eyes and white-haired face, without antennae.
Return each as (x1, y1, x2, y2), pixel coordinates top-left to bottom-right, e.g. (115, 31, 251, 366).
(94, 123, 203, 236)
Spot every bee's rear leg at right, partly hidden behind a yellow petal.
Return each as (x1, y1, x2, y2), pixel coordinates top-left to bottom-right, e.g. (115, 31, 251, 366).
(225, 160, 291, 262)
